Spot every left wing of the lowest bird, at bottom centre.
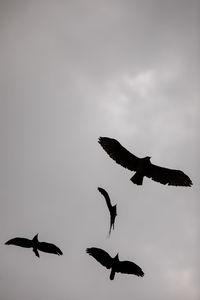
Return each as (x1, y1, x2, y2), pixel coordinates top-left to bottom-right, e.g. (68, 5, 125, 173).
(86, 247, 113, 269)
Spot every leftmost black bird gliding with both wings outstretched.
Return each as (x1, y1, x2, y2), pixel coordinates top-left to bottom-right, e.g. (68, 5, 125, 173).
(5, 234, 63, 257)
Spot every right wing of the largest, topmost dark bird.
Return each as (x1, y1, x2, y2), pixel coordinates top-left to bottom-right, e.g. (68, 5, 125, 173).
(145, 164, 192, 186)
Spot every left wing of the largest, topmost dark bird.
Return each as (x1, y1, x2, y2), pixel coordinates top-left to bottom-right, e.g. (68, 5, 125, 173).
(98, 137, 140, 171)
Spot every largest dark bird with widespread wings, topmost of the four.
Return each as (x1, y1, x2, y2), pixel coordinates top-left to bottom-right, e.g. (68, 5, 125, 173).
(98, 137, 193, 186)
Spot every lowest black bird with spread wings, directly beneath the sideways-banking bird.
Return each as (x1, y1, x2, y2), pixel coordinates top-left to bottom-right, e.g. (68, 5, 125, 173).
(86, 247, 144, 280)
